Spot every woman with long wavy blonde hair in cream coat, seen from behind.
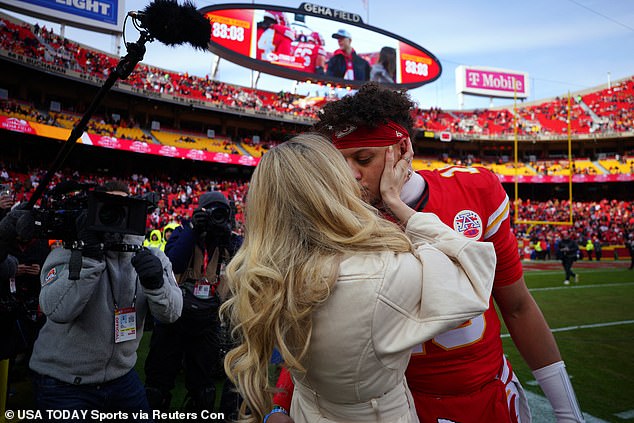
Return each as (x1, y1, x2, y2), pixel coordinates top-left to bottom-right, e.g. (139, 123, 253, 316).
(222, 134, 495, 423)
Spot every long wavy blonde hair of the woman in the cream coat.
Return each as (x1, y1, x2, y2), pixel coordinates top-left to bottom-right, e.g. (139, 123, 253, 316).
(221, 133, 412, 422)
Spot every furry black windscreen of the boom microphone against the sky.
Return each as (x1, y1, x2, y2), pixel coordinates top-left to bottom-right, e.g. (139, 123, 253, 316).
(128, 0, 211, 50)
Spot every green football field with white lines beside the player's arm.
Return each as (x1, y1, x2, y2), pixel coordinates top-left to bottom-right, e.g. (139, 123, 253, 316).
(502, 261, 634, 423)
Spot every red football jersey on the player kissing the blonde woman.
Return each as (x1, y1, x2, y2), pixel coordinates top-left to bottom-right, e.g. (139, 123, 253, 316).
(406, 166, 522, 398)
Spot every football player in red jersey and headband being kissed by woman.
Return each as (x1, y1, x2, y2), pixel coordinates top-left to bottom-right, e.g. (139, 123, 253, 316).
(269, 83, 584, 423)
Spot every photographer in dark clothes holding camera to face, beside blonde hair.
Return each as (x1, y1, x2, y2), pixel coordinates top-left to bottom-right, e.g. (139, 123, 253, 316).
(145, 192, 242, 417)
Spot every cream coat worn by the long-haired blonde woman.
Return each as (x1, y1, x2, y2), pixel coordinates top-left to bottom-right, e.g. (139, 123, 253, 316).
(291, 213, 496, 423)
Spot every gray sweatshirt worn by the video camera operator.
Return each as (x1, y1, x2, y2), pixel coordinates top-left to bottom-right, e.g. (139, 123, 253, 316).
(30, 235, 183, 384)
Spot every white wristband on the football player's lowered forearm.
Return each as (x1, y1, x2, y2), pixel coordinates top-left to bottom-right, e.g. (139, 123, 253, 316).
(533, 361, 585, 423)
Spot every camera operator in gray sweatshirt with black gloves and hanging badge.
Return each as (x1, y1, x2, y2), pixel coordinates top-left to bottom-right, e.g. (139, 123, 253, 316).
(30, 181, 182, 421)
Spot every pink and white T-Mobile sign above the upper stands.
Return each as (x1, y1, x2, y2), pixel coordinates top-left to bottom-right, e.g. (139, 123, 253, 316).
(456, 66, 529, 98)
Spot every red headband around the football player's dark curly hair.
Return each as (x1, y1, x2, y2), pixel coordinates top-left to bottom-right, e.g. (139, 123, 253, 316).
(332, 120, 409, 150)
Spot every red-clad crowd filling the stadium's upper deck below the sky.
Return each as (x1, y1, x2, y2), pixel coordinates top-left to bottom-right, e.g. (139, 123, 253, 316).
(0, 14, 634, 137)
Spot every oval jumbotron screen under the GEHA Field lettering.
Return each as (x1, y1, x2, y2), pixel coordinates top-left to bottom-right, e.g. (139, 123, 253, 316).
(200, 3, 442, 89)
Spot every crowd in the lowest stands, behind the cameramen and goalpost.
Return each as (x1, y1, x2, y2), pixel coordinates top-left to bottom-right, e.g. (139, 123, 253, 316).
(0, 164, 634, 252)
